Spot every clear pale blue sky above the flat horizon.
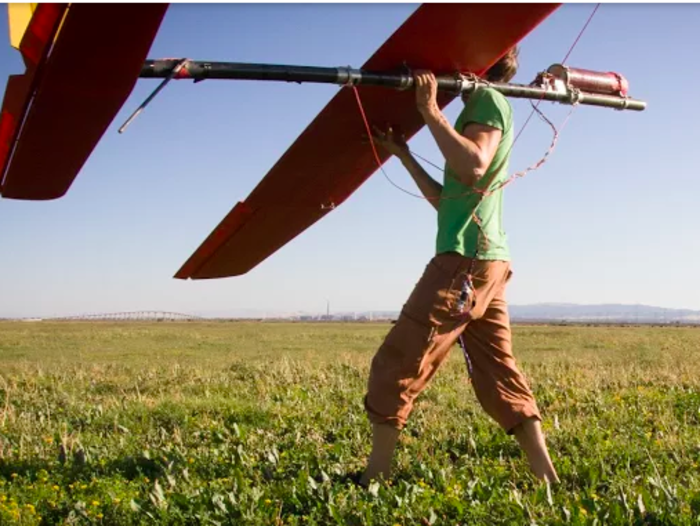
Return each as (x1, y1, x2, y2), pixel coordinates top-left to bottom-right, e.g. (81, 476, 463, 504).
(0, 4, 700, 316)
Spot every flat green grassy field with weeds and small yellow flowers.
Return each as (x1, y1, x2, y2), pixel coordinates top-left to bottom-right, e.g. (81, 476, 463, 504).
(0, 322, 700, 526)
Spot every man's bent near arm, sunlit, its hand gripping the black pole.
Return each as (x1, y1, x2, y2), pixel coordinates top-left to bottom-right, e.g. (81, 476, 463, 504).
(416, 72, 502, 186)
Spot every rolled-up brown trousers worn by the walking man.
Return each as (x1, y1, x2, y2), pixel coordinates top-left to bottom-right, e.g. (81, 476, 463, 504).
(364, 253, 541, 434)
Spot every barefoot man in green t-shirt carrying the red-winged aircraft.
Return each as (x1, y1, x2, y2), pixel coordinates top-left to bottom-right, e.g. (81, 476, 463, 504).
(360, 48, 558, 486)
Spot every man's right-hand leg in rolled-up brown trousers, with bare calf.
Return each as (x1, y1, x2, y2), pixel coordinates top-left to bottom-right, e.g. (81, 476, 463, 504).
(462, 271, 559, 482)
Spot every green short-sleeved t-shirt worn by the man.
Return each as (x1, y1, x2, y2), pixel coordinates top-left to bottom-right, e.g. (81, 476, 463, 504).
(436, 88, 513, 261)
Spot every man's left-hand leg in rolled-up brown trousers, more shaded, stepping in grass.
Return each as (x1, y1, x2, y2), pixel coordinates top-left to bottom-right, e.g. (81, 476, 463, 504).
(361, 254, 476, 485)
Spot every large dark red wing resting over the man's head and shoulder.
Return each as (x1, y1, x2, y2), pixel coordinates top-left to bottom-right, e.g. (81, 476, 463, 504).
(175, 3, 559, 279)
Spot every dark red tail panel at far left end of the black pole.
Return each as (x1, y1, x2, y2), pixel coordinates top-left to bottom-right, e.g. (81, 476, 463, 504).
(2, 3, 168, 200)
